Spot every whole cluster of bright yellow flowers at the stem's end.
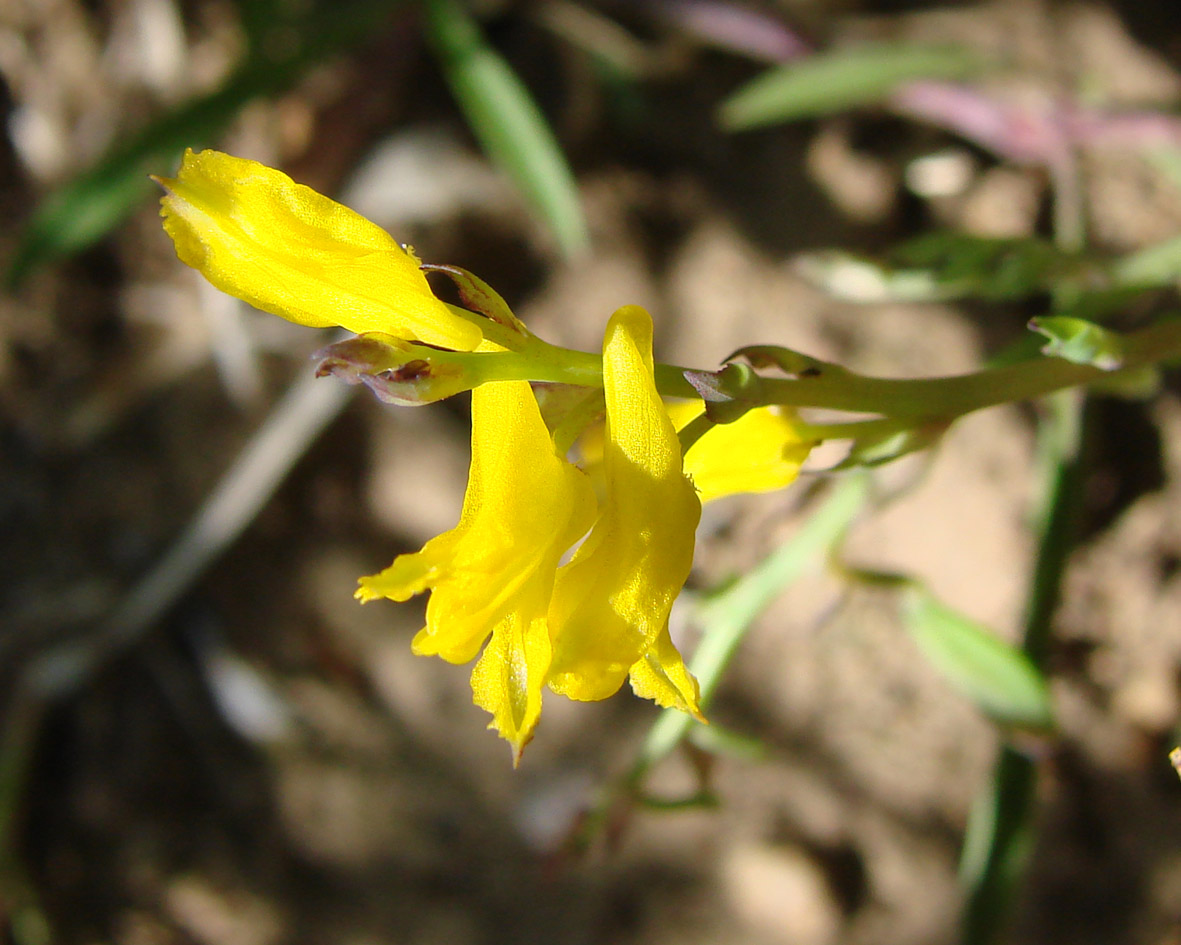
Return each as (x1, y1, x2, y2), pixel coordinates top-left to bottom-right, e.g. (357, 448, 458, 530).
(159, 151, 810, 761)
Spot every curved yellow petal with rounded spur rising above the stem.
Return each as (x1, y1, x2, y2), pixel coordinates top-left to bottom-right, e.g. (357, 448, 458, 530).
(549, 306, 702, 699)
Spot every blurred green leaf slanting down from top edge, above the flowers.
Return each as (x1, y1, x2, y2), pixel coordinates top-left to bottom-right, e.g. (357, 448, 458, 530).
(424, 0, 591, 258)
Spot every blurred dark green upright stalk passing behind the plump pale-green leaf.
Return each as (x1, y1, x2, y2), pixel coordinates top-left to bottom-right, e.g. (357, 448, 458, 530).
(960, 392, 1085, 945)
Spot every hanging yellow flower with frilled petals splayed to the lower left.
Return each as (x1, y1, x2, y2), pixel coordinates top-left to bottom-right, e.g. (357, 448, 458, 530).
(357, 380, 595, 760)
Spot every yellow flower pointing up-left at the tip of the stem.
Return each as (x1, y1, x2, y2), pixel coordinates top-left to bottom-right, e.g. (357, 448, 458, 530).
(157, 150, 482, 351)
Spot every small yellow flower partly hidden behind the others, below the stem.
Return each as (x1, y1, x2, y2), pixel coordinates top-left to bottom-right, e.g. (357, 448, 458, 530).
(678, 405, 816, 503)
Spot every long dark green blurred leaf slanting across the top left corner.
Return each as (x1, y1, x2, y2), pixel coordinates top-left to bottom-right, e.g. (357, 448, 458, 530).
(7, 0, 400, 286)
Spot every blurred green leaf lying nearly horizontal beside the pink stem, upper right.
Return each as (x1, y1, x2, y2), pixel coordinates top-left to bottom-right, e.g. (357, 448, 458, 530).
(718, 45, 985, 131)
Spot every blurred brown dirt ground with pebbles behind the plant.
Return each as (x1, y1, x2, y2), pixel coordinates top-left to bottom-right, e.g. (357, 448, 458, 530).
(0, 0, 1181, 945)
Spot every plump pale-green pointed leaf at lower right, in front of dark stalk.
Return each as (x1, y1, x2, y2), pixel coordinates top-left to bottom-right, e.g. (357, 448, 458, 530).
(905, 582, 1053, 732)
